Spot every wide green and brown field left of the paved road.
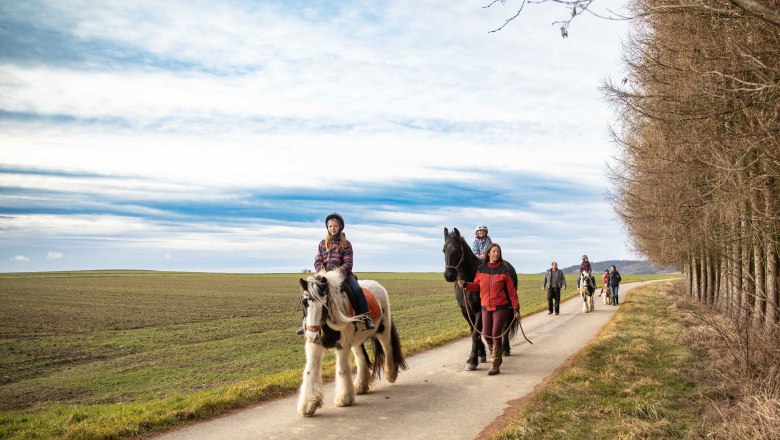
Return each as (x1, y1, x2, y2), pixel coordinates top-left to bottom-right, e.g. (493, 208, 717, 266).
(0, 271, 668, 438)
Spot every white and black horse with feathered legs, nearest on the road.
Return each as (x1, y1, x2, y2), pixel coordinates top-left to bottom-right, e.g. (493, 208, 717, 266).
(298, 270, 407, 416)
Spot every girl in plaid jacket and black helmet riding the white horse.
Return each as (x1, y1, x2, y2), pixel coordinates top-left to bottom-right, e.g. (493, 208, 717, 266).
(297, 212, 375, 335)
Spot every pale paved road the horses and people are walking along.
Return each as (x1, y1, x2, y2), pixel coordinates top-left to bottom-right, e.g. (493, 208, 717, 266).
(159, 283, 644, 440)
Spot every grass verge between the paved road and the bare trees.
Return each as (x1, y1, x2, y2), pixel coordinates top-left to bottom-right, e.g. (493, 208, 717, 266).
(491, 282, 711, 439)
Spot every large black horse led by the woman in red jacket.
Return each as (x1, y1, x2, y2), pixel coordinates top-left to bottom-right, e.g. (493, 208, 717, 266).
(443, 228, 519, 370)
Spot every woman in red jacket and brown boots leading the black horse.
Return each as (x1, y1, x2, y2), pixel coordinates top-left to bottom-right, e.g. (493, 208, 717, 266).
(458, 243, 520, 376)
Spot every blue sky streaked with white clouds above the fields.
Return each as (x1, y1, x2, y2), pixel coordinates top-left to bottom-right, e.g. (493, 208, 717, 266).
(0, 0, 641, 273)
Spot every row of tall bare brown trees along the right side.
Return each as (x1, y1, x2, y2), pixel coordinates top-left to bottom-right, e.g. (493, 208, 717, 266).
(604, 0, 780, 331)
